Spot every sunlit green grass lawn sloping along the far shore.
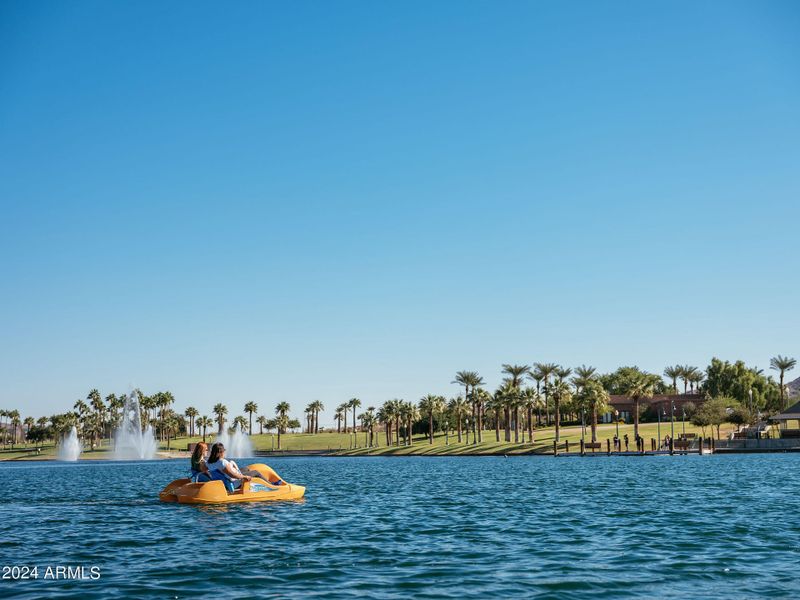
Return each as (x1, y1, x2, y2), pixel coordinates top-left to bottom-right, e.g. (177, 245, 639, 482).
(0, 422, 733, 460)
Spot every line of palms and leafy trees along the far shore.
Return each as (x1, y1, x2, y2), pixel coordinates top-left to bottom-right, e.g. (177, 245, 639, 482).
(0, 355, 796, 448)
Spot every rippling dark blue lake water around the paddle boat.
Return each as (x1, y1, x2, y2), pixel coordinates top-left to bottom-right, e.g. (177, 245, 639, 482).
(0, 454, 800, 599)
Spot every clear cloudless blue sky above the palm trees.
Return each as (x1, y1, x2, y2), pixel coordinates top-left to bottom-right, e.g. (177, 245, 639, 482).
(0, 0, 800, 424)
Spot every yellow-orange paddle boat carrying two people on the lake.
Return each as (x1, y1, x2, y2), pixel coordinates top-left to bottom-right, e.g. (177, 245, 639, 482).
(158, 463, 306, 504)
